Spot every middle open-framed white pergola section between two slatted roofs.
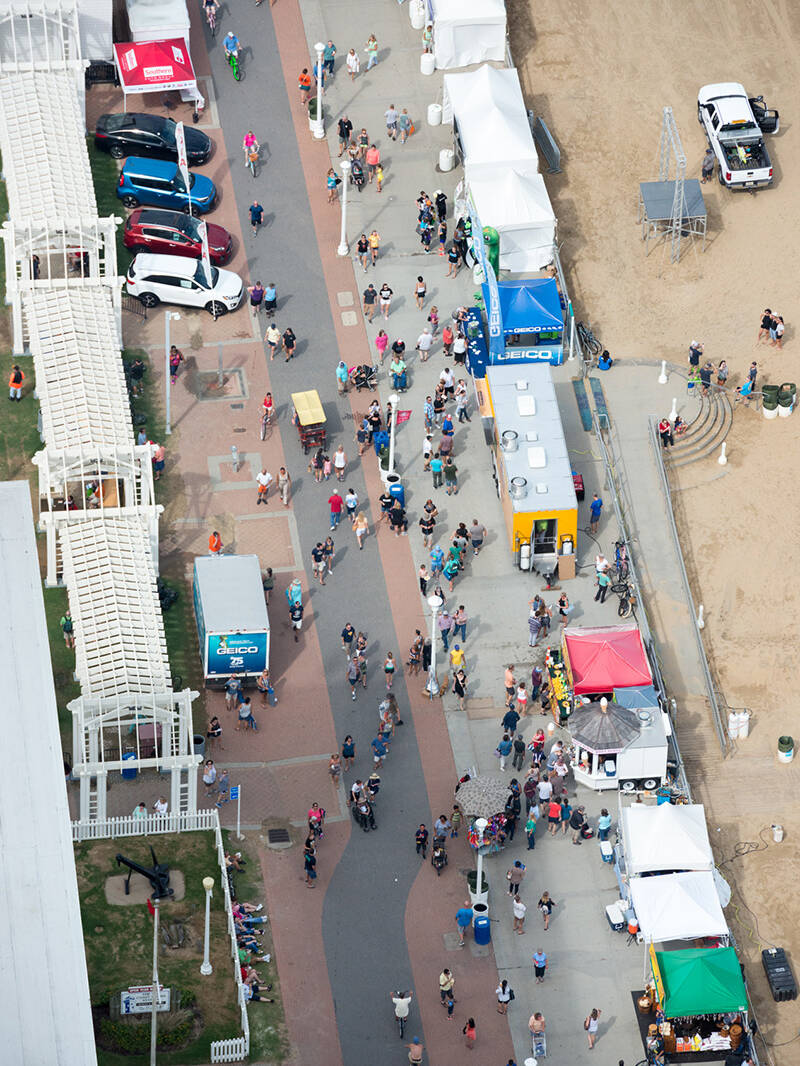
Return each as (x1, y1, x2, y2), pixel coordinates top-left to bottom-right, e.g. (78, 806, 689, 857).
(33, 445, 163, 588)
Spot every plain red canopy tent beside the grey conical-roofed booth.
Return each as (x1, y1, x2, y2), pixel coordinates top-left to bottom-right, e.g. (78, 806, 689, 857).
(563, 624, 653, 696)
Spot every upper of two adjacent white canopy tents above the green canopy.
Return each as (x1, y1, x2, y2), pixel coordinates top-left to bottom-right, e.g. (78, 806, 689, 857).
(621, 804, 714, 876)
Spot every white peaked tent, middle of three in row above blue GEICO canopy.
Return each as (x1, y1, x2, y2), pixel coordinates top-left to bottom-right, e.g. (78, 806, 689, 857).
(445, 66, 539, 174)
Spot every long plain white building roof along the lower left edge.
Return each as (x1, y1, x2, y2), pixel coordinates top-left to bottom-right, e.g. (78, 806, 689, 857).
(0, 481, 97, 1066)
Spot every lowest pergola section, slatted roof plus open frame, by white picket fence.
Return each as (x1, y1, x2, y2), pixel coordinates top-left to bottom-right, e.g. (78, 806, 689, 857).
(60, 516, 201, 821)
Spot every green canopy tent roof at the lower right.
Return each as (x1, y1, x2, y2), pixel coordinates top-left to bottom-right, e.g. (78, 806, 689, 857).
(650, 948, 748, 1018)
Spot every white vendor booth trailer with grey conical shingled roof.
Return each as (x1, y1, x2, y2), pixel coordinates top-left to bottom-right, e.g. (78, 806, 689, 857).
(567, 698, 667, 792)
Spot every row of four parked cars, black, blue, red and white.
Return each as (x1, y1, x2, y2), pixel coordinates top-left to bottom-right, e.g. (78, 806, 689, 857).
(95, 112, 244, 318)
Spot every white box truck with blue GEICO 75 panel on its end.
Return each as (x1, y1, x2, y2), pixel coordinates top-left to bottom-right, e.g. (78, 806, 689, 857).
(192, 555, 270, 689)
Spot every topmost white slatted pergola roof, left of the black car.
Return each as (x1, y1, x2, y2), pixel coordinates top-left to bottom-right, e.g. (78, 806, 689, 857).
(0, 71, 97, 220)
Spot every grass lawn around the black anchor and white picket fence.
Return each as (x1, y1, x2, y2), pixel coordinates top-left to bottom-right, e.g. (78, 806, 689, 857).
(75, 833, 287, 1066)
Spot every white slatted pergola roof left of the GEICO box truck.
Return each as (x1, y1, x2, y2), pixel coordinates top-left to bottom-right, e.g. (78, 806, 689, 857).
(60, 515, 172, 697)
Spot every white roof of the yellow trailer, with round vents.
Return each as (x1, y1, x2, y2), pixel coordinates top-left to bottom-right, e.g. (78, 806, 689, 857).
(486, 362, 578, 514)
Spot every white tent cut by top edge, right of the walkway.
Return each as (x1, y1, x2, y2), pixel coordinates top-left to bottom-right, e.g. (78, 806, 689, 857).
(431, 0, 506, 70)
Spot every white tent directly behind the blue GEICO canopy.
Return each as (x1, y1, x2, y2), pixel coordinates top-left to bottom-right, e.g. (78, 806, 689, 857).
(462, 166, 556, 274)
